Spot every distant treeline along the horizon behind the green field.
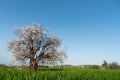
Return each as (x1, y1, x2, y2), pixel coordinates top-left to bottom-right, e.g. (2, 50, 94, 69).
(0, 60, 120, 69)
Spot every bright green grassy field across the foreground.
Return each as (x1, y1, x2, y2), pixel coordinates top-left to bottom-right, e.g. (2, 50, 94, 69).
(0, 68, 120, 80)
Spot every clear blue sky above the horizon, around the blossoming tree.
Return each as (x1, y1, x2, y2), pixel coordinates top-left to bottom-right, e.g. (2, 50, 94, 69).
(0, 0, 120, 65)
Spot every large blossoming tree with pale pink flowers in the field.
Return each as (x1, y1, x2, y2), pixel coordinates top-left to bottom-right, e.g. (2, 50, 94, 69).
(8, 24, 67, 70)
